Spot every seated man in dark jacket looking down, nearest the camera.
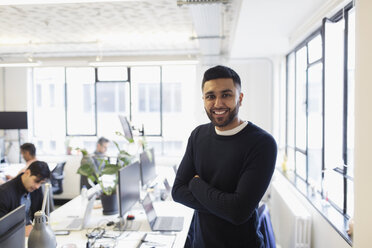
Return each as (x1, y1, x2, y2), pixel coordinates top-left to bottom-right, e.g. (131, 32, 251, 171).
(0, 161, 50, 235)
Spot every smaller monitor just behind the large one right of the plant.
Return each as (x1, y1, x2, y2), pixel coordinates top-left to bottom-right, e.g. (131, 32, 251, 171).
(140, 148, 156, 186)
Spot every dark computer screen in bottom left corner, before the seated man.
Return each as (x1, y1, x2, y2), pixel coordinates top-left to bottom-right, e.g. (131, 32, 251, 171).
(0, 205, 26, 248)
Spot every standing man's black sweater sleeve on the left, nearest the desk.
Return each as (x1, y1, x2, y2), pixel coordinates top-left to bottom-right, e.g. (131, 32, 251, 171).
(172, 137, 209, 212)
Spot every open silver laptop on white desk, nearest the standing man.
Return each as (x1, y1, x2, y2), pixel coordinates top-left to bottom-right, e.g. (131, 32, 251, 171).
(142, 194, 183, 232)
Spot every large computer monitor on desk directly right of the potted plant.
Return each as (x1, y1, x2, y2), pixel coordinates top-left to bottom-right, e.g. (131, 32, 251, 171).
(118, 161, 141, 218)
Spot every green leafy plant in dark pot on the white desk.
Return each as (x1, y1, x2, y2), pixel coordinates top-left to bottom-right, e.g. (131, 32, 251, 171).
(77, 135, 134, 215)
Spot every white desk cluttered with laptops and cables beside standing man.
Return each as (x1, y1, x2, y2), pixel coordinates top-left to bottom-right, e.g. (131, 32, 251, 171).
(50, 196, 194, 248)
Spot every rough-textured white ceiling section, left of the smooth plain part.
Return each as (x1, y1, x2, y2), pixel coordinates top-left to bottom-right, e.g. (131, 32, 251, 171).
(0, 0, 238, 60)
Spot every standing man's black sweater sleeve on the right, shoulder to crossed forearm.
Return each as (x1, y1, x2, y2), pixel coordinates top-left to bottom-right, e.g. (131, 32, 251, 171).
(189, 136, 277, 225)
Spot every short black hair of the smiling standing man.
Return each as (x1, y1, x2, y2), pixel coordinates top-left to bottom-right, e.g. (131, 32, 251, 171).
(202, 65, 241, 90)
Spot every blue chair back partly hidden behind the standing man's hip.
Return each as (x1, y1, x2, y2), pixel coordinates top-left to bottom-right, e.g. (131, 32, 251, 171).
(258, 204, 276, 248)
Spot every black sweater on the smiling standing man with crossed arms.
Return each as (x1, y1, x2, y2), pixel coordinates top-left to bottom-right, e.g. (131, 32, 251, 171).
(172, 123, 277, 248)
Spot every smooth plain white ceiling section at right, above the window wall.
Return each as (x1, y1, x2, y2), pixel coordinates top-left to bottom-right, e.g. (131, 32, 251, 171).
(230, 0, 335, 58)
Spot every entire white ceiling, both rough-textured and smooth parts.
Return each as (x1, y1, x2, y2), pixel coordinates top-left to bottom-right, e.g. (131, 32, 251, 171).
(0, 0, 338, 61)
